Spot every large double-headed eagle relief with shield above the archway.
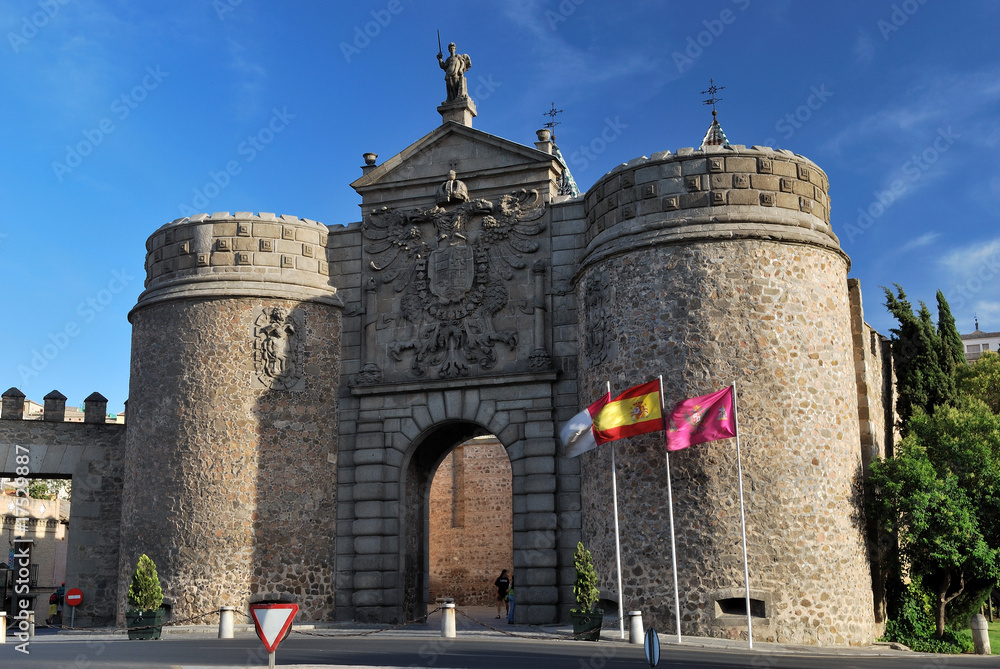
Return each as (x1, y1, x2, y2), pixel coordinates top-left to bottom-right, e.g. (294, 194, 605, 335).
(362, 172, 545, 378)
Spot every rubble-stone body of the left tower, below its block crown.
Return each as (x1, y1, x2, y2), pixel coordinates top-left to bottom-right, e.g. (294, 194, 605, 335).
(120, 298, 340, 620)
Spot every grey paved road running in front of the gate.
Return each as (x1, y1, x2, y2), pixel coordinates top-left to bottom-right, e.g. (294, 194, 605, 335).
(0, 634, 997, 669)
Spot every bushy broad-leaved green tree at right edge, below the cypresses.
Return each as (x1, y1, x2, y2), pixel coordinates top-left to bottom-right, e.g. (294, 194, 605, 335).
(871, 398, 1000, 639)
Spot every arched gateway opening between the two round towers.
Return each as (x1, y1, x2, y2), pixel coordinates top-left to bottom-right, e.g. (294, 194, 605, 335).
(402, 422, 513, 620)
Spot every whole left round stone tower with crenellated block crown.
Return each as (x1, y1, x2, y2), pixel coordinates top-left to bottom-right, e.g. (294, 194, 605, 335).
(119, 212, 342, 623)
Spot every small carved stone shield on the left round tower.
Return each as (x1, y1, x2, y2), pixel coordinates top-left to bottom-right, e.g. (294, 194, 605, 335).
(254, 307, 305, 391)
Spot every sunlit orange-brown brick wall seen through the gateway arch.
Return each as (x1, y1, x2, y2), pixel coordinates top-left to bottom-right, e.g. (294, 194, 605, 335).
(428, 438, 513, 606)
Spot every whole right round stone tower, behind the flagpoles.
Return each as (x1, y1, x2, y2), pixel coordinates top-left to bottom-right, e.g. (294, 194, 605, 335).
(577, 145, 875, 644)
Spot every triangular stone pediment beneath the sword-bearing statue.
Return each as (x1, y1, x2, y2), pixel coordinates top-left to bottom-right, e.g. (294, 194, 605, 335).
(351, 122, 561, 211)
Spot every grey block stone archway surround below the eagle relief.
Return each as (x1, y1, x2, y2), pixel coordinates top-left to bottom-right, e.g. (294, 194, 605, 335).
(336, 376, 580, 624)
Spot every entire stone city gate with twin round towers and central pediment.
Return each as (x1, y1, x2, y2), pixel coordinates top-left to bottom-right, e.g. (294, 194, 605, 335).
(0, 66, 893, 644)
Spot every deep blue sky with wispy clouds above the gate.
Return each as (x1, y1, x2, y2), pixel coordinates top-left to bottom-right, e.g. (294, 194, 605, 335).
(0, 0, 1000, 411)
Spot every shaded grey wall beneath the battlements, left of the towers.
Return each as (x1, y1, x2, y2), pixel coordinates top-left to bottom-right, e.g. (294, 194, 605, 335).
(0, 420, 125, 627)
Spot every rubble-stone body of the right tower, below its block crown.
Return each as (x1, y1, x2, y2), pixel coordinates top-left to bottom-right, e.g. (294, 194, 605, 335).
(583, 242, 872, 644)
